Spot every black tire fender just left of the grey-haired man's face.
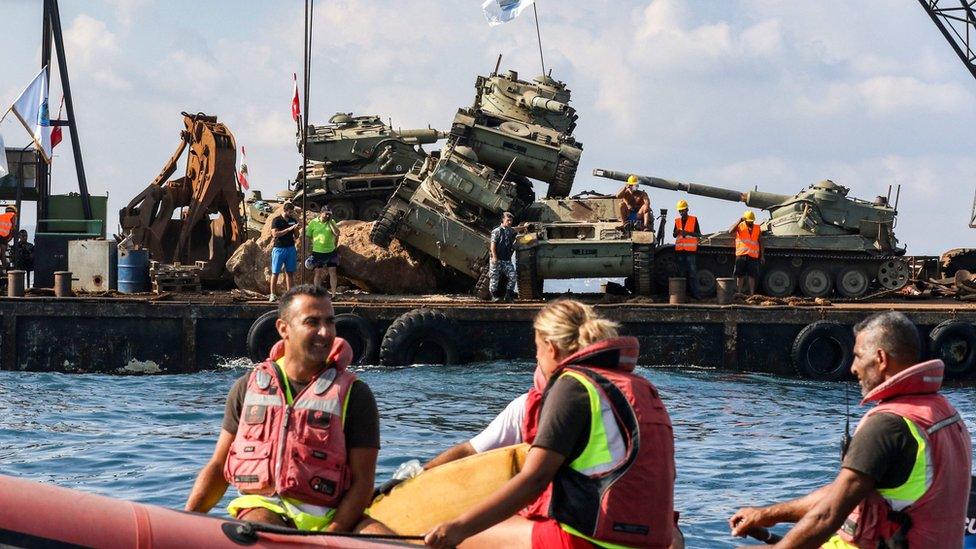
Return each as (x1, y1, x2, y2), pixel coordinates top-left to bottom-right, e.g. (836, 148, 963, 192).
(790, 320, 854, 381)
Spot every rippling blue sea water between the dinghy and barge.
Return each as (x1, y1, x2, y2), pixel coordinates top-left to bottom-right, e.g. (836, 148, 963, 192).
(0, 363, 976, 547)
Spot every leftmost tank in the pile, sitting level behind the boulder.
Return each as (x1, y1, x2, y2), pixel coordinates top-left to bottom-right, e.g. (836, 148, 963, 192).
(289, 113, 447, 221)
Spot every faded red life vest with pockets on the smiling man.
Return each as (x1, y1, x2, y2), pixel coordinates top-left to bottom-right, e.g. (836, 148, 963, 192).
(224, 337, 356, 507)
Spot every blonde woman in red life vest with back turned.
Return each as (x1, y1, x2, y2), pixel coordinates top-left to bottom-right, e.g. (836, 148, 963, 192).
(425, 300, 676, 549)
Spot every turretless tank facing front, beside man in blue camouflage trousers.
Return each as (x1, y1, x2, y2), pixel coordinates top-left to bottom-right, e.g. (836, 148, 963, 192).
(515, 196, 663, 300)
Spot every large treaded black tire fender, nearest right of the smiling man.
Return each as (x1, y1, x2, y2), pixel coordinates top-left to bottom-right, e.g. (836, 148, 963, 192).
(380, 309, 466, 366)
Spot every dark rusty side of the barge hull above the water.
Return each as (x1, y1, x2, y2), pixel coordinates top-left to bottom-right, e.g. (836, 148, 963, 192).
(0, 296, 976, 376)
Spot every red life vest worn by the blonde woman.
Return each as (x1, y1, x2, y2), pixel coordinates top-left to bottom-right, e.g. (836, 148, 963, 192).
(521, 337, 675, 548)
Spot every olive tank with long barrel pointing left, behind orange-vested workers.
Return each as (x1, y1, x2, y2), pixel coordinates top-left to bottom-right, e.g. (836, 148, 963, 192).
(593, 169, 911, 298)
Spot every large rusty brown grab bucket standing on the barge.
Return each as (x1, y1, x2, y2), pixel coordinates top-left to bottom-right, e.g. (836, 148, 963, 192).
(119, 112, 246, 281)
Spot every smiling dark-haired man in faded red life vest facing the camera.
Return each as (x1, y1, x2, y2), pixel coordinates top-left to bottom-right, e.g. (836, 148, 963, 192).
(185, 284, 386, 533)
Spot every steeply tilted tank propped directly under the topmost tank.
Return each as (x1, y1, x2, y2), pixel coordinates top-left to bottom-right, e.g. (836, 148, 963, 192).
(370, 145, 535, 295)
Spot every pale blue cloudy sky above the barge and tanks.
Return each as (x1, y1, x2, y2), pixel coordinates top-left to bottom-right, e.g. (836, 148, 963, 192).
(0, 0, 976, 255)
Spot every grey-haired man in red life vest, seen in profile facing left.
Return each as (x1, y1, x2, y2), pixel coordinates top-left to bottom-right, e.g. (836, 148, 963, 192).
(729, 311, 972, 549)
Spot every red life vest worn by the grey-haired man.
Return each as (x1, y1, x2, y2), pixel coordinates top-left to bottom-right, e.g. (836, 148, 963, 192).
(838, 360, 972, 549)
